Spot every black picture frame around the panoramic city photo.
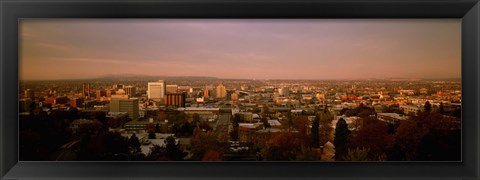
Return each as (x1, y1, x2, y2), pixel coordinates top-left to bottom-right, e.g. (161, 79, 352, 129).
(0, 0, 480, 179)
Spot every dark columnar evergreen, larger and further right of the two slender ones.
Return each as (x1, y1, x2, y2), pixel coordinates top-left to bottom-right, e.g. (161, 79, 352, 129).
(333, 118, 350, 161)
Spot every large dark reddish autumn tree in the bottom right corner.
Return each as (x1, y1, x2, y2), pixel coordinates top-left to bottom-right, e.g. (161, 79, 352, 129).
(388, 110, 461, 161)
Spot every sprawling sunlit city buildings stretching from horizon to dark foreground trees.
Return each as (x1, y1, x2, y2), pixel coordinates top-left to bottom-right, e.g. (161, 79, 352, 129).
(19, 79, 461, 160)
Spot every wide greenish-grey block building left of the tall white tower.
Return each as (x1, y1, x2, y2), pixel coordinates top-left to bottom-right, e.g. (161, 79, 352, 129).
(110, 95, 139, 120)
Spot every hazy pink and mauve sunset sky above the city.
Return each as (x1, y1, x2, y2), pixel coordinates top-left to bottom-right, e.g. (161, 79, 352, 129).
(19, 19, 461, 80)
